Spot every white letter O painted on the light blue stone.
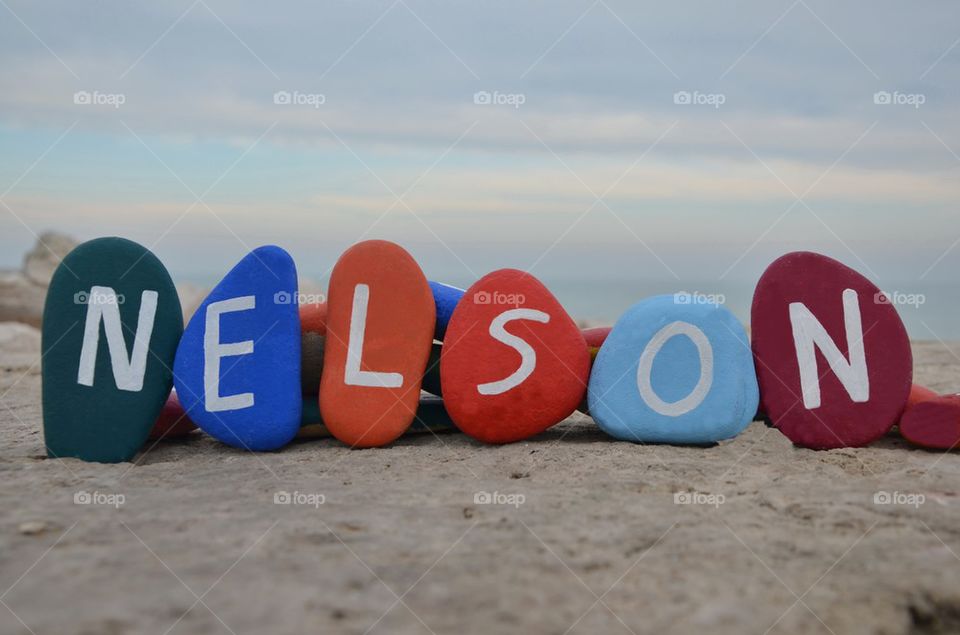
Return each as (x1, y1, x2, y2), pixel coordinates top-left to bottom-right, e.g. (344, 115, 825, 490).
(637, 322, 713, 417)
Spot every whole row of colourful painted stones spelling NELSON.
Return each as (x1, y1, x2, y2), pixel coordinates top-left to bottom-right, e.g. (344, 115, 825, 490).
(43, 238, 936, 462)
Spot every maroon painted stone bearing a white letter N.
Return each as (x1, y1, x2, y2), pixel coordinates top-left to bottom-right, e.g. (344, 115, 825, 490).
(751, 252, 913, 449)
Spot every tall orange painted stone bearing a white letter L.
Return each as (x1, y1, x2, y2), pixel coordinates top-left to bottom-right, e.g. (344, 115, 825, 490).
(320, 240, 436, 447)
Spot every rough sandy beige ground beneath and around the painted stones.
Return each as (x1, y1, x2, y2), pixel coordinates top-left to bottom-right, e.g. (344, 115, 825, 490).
(0, 325, 960, 635)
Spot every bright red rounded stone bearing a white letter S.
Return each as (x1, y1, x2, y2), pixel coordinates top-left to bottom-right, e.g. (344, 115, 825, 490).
(440, 269, 590, 443)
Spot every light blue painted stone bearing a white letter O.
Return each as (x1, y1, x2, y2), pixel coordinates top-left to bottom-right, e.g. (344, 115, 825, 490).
(587, 295, 760, 444)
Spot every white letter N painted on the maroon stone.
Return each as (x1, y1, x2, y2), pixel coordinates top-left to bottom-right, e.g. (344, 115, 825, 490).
(790, 289, 870, 410)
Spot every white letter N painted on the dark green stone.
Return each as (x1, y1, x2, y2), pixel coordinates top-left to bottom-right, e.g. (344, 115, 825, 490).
(77, 287, 158, 392)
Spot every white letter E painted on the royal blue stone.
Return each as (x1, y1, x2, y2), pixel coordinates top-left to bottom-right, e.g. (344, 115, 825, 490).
(203, 295, 257, 412)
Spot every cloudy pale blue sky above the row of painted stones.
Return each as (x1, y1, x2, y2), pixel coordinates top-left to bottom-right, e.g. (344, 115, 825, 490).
(0, 0, 960, 336)
